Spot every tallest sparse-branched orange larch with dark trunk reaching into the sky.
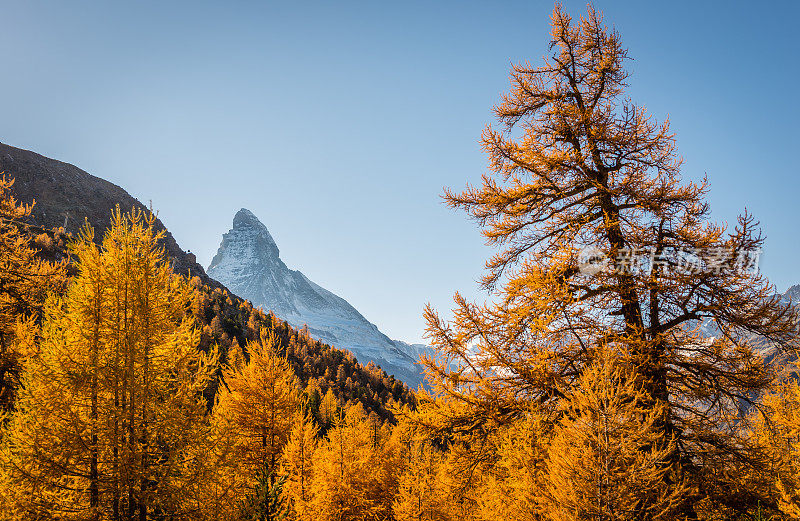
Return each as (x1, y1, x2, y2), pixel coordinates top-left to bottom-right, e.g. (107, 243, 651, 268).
(421, 6, 796, 517)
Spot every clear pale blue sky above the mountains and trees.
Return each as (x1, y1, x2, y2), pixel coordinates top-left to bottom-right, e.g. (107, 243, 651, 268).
(0, 0, 800, 341)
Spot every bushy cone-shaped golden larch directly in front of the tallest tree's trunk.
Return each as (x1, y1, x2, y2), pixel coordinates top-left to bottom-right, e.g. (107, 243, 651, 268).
(541, 357, 688, 521)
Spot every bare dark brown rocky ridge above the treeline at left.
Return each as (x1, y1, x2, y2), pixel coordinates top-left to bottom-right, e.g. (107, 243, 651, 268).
(0, 143, 215, 285)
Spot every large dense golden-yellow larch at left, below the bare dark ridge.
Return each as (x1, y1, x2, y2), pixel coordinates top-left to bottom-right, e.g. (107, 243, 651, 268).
(0, 209, 217, 520)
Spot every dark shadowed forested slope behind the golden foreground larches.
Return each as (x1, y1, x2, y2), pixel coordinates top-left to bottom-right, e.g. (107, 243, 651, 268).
(4, 177, 413, 420)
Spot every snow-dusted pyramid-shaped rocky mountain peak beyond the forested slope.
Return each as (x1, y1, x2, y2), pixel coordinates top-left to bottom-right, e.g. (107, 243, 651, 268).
(208, 208, 426, 388)
